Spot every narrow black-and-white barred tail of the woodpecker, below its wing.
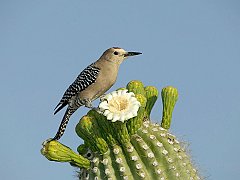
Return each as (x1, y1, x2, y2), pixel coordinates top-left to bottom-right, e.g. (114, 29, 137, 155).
(52, 107, 76, 140)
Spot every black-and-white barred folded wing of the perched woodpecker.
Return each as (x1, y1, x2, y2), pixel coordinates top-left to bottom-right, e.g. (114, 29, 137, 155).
(54, 63, 100, 114)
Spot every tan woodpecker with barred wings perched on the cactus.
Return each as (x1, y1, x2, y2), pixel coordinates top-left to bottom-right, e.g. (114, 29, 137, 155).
(52, 47, 142, 140)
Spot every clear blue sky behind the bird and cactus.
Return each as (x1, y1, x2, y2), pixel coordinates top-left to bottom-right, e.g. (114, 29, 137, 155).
(0, 0, 240, 180)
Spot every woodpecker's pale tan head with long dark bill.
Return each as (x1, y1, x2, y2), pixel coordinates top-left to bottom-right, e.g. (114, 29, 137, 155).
(101, 47, 142, 64)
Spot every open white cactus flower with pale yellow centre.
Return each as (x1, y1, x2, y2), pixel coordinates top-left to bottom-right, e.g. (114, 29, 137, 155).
(98, 89, 141, 122)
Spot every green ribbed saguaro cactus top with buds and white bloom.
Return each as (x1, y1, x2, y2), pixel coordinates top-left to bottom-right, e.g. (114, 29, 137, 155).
(41, 81, 200, 180)
